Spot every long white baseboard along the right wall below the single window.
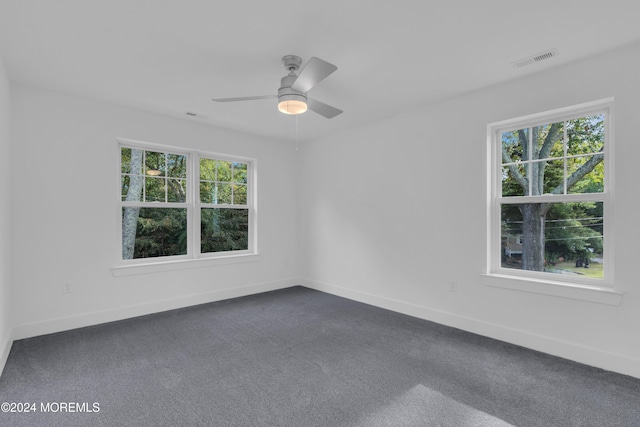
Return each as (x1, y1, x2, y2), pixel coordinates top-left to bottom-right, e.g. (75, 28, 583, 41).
(298, 279, 640, 378)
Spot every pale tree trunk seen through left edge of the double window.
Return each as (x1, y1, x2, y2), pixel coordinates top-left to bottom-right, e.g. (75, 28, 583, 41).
(122, 149, 144, 259)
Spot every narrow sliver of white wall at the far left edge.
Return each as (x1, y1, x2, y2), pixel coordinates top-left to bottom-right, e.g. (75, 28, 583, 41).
(0, 58, 12, 373)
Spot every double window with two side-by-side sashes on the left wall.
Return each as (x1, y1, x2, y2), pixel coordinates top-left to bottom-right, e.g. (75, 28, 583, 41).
(120, 141, 255, 263)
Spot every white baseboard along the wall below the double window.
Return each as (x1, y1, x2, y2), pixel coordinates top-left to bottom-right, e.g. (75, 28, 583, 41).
(9, 279, 300, 342)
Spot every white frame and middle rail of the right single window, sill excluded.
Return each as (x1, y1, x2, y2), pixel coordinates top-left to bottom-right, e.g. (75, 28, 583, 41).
(484, 98, 618, 300)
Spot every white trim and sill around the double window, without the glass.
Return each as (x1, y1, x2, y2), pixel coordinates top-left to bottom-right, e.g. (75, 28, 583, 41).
(111, 138, 259, 276)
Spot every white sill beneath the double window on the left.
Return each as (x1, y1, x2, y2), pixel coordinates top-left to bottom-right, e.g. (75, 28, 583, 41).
(111, 254, 259, 277)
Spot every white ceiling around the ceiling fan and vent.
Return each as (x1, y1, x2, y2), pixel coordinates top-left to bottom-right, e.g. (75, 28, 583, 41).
(0, 0, 640, 141)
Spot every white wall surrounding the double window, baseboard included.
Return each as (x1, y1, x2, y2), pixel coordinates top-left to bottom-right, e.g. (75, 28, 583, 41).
(10, 84, 298, 339)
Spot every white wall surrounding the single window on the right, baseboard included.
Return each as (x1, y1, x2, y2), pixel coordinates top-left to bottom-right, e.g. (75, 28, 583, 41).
(299, 45, 640, 377)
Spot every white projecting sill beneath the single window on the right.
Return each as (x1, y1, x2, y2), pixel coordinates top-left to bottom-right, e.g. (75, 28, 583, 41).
(482, 274, 623, 305)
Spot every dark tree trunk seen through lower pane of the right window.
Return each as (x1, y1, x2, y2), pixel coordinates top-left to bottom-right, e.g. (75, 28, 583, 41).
(520, 203, 548, 271)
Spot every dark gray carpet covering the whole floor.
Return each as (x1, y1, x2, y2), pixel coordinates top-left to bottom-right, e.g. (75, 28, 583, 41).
(0, 287, 640, 427)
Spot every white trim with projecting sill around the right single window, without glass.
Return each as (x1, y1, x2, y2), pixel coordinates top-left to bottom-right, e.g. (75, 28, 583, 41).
(482, 98, 623, 305)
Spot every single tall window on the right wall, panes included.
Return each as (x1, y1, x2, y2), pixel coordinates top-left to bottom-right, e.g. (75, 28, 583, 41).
(488, 100, 612, 286)
